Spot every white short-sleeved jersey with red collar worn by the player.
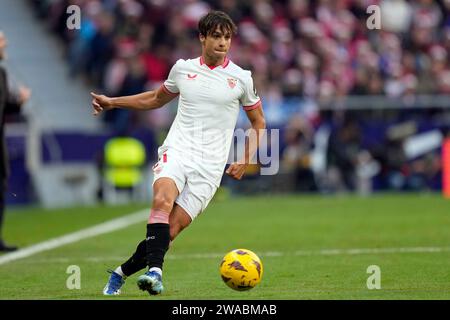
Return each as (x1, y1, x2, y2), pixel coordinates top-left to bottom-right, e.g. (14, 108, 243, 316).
(158, 57, 261, 186)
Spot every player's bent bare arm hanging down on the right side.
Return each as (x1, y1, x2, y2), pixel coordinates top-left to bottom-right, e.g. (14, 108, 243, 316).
(226, 103, 266, 180)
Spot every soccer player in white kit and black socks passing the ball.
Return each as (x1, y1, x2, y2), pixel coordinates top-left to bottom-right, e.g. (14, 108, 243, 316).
(92, 11, 265, 295)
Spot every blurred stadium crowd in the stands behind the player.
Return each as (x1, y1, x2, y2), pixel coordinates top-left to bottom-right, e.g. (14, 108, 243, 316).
(29, 0, 450, 191)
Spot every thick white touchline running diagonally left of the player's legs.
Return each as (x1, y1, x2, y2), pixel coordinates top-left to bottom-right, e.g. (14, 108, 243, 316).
(0, 209, 149, 265)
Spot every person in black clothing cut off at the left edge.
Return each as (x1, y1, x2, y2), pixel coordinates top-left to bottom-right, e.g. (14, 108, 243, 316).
(0, 31, 31, 252)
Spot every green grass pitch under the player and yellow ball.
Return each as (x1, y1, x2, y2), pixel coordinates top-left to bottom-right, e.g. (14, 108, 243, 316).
(0, 194, 450, 300)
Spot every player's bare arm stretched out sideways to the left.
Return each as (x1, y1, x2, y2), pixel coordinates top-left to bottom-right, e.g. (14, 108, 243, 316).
(91, 86, 177, 116)
